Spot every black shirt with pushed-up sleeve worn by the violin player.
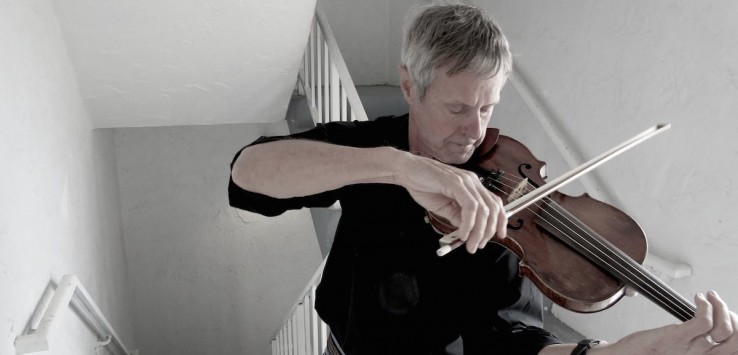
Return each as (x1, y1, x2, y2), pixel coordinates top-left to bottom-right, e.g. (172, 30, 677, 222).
(228, 115, 559, 355)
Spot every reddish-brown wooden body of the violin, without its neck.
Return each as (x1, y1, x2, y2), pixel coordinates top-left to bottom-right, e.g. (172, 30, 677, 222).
(428, 128, 647, 313)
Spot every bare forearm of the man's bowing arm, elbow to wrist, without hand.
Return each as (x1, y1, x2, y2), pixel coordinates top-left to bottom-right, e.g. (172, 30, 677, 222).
(232, 139, 409, 198)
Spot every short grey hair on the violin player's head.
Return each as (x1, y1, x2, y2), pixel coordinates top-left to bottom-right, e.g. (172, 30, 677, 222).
(400, 3, 512, 101)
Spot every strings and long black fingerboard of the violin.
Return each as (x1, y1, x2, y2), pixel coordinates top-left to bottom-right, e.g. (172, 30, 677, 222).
(486, 173, 694, 320)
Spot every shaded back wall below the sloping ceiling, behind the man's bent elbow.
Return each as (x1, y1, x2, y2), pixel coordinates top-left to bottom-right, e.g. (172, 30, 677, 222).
(115, 122, 321, 355)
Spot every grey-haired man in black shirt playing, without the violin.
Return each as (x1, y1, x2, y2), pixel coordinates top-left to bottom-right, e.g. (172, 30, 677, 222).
(229, 5, 738, 355)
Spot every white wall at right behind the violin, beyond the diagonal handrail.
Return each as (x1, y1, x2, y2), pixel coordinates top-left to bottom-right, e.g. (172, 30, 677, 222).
(482, 1, 738, 339)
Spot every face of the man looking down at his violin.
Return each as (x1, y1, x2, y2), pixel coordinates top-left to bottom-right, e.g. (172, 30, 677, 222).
(400, 63, 506, 164)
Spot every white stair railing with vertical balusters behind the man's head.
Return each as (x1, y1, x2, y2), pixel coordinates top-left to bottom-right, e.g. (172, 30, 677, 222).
(299, 4, 368, 124)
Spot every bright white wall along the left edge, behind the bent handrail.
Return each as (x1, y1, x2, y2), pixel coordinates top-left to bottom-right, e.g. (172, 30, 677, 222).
(0, 0, 136, 355)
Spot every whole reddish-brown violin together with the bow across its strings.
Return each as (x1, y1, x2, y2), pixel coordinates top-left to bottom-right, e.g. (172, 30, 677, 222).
(427, 127, 695, 321)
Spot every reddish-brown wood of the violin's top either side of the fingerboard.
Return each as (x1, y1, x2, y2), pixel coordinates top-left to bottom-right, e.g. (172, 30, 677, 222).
(478, 132, 647, 312)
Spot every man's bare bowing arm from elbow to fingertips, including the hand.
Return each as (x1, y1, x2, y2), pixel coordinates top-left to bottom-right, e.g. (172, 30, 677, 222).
(231, 139, 507, 253)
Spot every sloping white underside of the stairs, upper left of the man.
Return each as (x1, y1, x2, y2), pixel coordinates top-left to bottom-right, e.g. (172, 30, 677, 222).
(54, 0, 315, 127)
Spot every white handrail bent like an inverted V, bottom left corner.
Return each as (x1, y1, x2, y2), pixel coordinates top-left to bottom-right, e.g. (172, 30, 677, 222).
(15, 274, 138, 355)
